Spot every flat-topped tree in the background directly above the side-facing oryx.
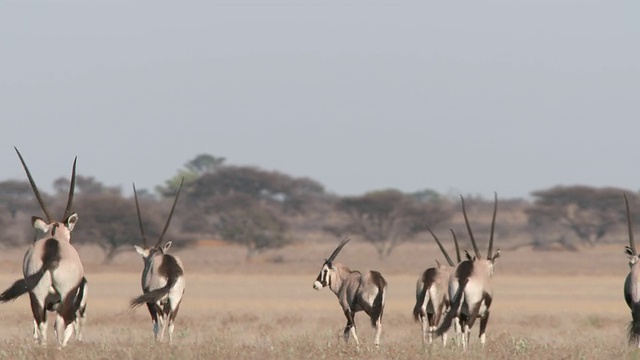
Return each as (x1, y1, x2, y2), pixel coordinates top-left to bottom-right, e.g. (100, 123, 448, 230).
(327, 189, 451, 259)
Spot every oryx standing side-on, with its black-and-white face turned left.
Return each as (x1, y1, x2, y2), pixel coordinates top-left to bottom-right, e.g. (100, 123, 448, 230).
(313, 238, 387, 346)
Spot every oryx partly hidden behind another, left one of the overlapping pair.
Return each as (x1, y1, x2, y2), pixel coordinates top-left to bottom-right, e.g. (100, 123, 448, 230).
(413, 227, 460, 346)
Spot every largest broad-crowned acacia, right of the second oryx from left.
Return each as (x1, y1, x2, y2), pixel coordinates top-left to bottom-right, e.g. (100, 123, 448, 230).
(186, 166, 323, 259)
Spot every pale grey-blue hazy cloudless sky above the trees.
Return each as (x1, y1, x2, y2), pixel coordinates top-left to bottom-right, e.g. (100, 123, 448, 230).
(0, 0, 640, 197)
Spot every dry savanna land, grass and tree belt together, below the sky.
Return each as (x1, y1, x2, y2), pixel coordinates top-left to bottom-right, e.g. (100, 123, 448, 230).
(0, 159, 640, 359)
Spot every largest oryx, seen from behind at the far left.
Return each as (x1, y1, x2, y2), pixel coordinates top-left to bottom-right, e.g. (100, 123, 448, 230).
(0, 148, 86, 347)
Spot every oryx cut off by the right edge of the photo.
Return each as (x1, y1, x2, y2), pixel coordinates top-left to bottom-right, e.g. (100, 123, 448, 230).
(624, 194, 640, 348)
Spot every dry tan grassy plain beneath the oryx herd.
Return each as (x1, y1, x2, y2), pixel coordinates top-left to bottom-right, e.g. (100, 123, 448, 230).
(0, 242, 640, 360)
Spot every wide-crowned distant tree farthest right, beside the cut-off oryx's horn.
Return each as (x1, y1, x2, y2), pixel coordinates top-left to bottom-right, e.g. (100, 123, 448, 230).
(526, 185, 640, 246)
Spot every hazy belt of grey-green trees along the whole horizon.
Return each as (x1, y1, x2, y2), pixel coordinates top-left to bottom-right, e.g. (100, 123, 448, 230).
(0, 154, 640, 262)
